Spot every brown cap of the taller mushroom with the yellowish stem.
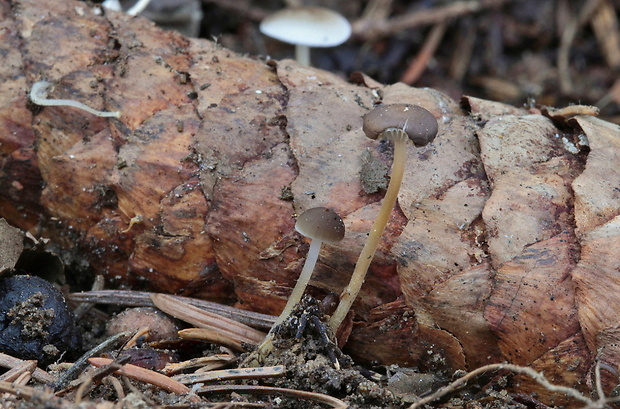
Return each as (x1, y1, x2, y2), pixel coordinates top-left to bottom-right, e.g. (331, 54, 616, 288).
(362, 104, 438, 147)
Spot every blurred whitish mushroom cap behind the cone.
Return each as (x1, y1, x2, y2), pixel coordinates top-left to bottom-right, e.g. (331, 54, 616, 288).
(259, 7, 351, 47)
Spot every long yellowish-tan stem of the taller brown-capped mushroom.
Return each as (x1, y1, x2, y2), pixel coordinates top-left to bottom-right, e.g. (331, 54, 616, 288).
(329, 128, 409, 334)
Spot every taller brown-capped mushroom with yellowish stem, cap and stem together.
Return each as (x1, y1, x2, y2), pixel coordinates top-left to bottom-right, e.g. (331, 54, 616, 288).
(329, 104, 437, 333)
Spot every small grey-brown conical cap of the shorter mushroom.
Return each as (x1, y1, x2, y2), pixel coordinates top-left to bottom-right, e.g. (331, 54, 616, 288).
(295, 207, 344, 242)
